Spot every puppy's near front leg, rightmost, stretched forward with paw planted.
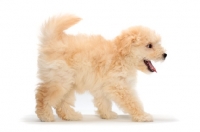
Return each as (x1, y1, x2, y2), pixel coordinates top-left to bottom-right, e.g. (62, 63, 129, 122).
(104, 87, 153, 122)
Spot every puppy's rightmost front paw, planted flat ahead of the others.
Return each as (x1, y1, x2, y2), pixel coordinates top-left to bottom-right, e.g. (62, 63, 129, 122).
(132, 113, 153, 122)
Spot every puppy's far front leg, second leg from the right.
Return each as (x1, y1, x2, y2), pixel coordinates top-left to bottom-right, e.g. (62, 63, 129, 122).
(94, 95, 117, 119)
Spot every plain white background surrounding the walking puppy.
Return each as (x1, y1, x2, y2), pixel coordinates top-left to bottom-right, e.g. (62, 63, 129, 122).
(0, 0, 200, 132)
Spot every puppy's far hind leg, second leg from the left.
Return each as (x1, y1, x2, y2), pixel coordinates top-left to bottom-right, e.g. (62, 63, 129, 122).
(56, 90, 82, 121)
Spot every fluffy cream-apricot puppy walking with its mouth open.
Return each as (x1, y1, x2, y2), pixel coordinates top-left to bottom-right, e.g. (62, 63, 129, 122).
(36, 15, 167, 122)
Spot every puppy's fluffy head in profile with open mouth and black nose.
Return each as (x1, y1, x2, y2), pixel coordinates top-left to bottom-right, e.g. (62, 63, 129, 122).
(115, 26, 167, 73)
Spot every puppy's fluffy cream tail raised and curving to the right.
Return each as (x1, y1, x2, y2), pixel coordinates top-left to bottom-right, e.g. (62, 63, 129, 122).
(40, 14, 81, 42)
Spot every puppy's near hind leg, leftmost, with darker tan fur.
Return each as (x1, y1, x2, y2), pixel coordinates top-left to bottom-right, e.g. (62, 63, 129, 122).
(36, 83, 66, 122)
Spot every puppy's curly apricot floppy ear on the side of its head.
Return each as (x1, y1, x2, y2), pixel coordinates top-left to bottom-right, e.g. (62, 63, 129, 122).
(115, 34, 135, 56)
